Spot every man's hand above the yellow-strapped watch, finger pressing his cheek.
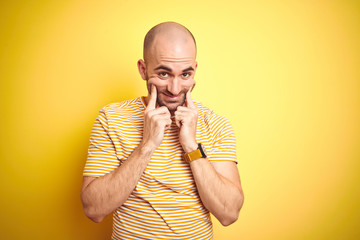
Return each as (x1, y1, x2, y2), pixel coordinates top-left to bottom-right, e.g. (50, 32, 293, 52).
(175, 89, 198, 152)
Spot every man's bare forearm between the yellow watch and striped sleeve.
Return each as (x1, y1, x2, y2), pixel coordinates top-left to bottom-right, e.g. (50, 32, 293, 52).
(190, 158, 244, 226)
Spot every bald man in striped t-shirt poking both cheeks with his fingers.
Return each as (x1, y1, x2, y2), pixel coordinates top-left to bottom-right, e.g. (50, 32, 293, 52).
(81, 22, 244, 239)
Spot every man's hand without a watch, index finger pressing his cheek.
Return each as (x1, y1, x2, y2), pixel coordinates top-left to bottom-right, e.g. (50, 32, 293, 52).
(141, 85, 171, 150)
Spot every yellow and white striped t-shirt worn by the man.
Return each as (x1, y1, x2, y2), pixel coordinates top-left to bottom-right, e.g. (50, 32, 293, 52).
(84, 97, 236, 239)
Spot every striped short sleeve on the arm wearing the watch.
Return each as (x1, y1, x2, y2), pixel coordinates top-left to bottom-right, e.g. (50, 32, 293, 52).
(209, 117, 237, 163)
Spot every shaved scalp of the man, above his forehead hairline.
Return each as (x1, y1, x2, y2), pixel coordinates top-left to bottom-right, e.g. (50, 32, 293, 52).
(143, 22, 196, 63)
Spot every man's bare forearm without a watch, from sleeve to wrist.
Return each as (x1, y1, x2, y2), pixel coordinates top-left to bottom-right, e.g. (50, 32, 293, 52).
(81, 145, 153, 222)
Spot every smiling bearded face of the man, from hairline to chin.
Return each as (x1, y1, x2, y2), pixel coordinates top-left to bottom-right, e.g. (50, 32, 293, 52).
(146, 36, 197, 112)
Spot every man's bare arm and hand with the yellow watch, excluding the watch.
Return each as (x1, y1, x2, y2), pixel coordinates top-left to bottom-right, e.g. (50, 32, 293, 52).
(175, 91, 244, 226)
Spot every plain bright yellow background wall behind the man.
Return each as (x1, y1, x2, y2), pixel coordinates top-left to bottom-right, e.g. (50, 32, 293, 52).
(0, 0, 360, 240)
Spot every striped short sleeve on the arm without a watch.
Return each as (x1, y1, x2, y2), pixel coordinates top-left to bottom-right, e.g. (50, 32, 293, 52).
(83, 108, 119, 177)
